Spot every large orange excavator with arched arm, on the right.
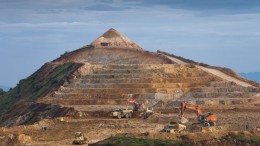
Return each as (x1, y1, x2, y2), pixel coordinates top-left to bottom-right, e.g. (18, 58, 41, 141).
(180, 102, 217, 126)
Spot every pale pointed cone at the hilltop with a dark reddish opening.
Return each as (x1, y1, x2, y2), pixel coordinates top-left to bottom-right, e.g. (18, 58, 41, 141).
(91, 28, 143, 51)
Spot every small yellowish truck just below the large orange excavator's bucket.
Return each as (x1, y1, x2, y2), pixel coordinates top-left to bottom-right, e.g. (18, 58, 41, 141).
(164, 122, 187, 133)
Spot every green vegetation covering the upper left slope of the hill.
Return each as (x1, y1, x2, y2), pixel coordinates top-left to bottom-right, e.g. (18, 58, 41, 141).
(0, 62, 79, 114)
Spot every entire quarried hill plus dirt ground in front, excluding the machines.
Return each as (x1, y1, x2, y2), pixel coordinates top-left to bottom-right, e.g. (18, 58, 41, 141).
(0, 29, 260, 146)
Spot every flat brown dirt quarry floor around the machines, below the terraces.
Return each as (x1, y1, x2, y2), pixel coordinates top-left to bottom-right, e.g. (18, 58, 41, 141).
(0, 102, 260, 146)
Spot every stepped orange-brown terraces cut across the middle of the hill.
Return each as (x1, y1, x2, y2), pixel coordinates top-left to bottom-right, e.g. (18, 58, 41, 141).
(38, 64, 258, 105)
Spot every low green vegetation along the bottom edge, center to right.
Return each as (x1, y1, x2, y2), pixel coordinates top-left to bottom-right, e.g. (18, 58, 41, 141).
(98, 131, 260, 146)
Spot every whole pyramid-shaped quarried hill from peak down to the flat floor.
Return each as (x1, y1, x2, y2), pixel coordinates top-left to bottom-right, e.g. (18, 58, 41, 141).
(0, 29, 260, 126)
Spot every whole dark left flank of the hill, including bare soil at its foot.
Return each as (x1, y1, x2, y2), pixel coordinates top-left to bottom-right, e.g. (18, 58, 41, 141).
(0, 63, 82, 126)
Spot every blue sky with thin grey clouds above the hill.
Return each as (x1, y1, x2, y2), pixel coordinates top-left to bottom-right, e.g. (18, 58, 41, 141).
(0, 0, 260, 87)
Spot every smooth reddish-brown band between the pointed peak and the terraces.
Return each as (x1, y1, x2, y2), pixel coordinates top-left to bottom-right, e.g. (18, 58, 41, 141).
(52, 45, 174, 64)
